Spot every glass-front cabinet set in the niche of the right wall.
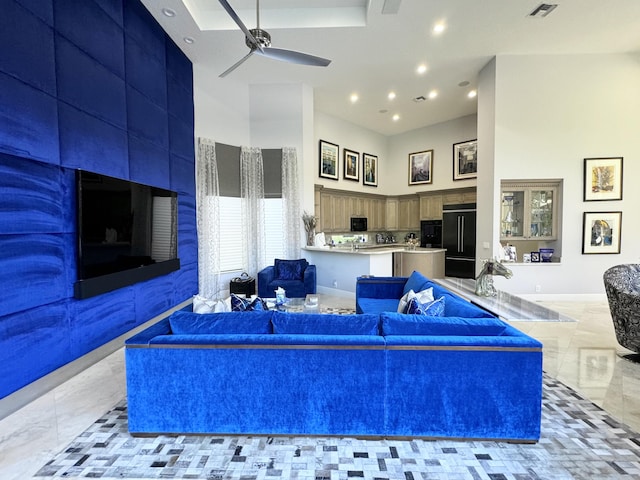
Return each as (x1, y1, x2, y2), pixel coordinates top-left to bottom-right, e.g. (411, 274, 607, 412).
(500, 181, 560, 241)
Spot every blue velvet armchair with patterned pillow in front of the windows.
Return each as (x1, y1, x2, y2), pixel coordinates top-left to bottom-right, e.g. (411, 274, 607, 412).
(258, 258, 316, 298)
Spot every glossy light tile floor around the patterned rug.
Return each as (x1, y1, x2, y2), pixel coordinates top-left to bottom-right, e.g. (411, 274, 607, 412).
(0, 297, 640, 480)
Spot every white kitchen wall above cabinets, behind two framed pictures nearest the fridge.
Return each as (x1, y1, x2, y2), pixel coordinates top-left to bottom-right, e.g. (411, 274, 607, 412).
(382, 115, 477, 195)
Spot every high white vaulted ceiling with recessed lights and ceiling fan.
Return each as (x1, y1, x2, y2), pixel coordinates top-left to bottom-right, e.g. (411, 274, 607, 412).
(142, 0, 640, 135)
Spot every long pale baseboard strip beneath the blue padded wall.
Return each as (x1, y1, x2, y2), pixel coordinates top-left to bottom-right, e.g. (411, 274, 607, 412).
(0, 298, 193, 420)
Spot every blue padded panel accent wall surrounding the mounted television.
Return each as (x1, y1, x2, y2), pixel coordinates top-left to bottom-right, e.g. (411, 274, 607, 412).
(0, 0, 198, 398)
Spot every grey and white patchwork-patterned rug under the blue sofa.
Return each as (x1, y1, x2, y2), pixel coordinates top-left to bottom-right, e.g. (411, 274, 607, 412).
(36, 376, 640, 480)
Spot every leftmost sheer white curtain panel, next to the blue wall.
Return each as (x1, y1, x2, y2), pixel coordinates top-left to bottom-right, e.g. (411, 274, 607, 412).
(196, 138, 220, 299)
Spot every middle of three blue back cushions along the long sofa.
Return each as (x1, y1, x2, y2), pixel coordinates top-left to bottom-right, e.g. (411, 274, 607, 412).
(271, 312, 380, 335)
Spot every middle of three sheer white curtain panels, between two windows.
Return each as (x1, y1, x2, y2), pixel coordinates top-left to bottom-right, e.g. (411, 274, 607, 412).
(239, 147, 266, 276)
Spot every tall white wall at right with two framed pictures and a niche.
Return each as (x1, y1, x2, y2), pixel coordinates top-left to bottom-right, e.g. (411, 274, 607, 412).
(488, 54, 640, 294)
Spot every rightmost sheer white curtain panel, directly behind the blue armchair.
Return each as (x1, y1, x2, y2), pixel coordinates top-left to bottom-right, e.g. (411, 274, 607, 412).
(282, 147, 302, 259)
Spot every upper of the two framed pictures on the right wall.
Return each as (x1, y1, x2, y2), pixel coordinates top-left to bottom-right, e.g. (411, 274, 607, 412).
(584, 157, 622, 202)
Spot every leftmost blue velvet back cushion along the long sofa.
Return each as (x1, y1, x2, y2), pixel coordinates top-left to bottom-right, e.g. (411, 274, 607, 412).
(169, 311, 273, 335)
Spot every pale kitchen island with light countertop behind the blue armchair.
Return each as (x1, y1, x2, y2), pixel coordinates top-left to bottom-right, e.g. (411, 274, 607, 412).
(303, 244, 446, 296)
